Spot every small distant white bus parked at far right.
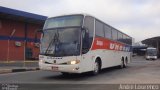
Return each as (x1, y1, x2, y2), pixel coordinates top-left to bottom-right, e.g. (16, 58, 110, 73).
(146, 47, 158, 60)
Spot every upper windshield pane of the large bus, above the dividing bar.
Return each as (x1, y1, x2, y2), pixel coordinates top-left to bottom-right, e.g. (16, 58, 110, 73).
(44, 15, 83, 29)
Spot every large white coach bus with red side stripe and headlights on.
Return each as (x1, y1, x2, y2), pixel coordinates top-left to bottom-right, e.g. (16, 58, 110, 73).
(39, 14, 132, 75)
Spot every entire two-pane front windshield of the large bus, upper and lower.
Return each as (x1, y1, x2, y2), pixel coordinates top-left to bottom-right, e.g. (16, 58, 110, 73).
(40, 15, 83, 57)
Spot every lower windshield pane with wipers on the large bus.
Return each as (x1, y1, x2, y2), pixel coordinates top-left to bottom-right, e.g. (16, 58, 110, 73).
(40, 28, 80, 57)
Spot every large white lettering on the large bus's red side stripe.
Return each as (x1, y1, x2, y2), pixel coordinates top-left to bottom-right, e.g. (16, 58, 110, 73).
(109, 43, 130, 51)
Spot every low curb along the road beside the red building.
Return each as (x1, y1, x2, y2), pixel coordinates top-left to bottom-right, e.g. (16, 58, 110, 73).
(0, 68, 40, 74)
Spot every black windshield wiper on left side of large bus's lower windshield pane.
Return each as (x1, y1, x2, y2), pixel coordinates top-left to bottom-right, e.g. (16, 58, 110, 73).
(45, 32, 59, 55)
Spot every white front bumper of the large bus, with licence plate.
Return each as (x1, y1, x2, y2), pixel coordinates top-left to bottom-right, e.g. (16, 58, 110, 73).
(39, 62, 81, 73)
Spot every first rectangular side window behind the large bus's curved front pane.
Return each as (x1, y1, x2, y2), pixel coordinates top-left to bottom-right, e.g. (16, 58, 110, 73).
(96, 20, 104, 37)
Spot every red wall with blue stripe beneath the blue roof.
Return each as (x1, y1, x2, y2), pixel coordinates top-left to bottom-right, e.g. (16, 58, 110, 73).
(0, 19, 42, 60)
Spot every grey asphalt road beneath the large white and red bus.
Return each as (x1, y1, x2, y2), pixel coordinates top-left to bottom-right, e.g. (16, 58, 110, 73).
(0, 57, 160, 89)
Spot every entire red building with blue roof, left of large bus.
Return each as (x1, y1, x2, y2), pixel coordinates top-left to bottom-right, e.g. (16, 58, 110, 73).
(0, 7, 47, 61)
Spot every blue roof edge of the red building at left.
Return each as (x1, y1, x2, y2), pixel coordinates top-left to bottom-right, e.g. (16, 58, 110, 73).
(0, 6, 47, 23)
